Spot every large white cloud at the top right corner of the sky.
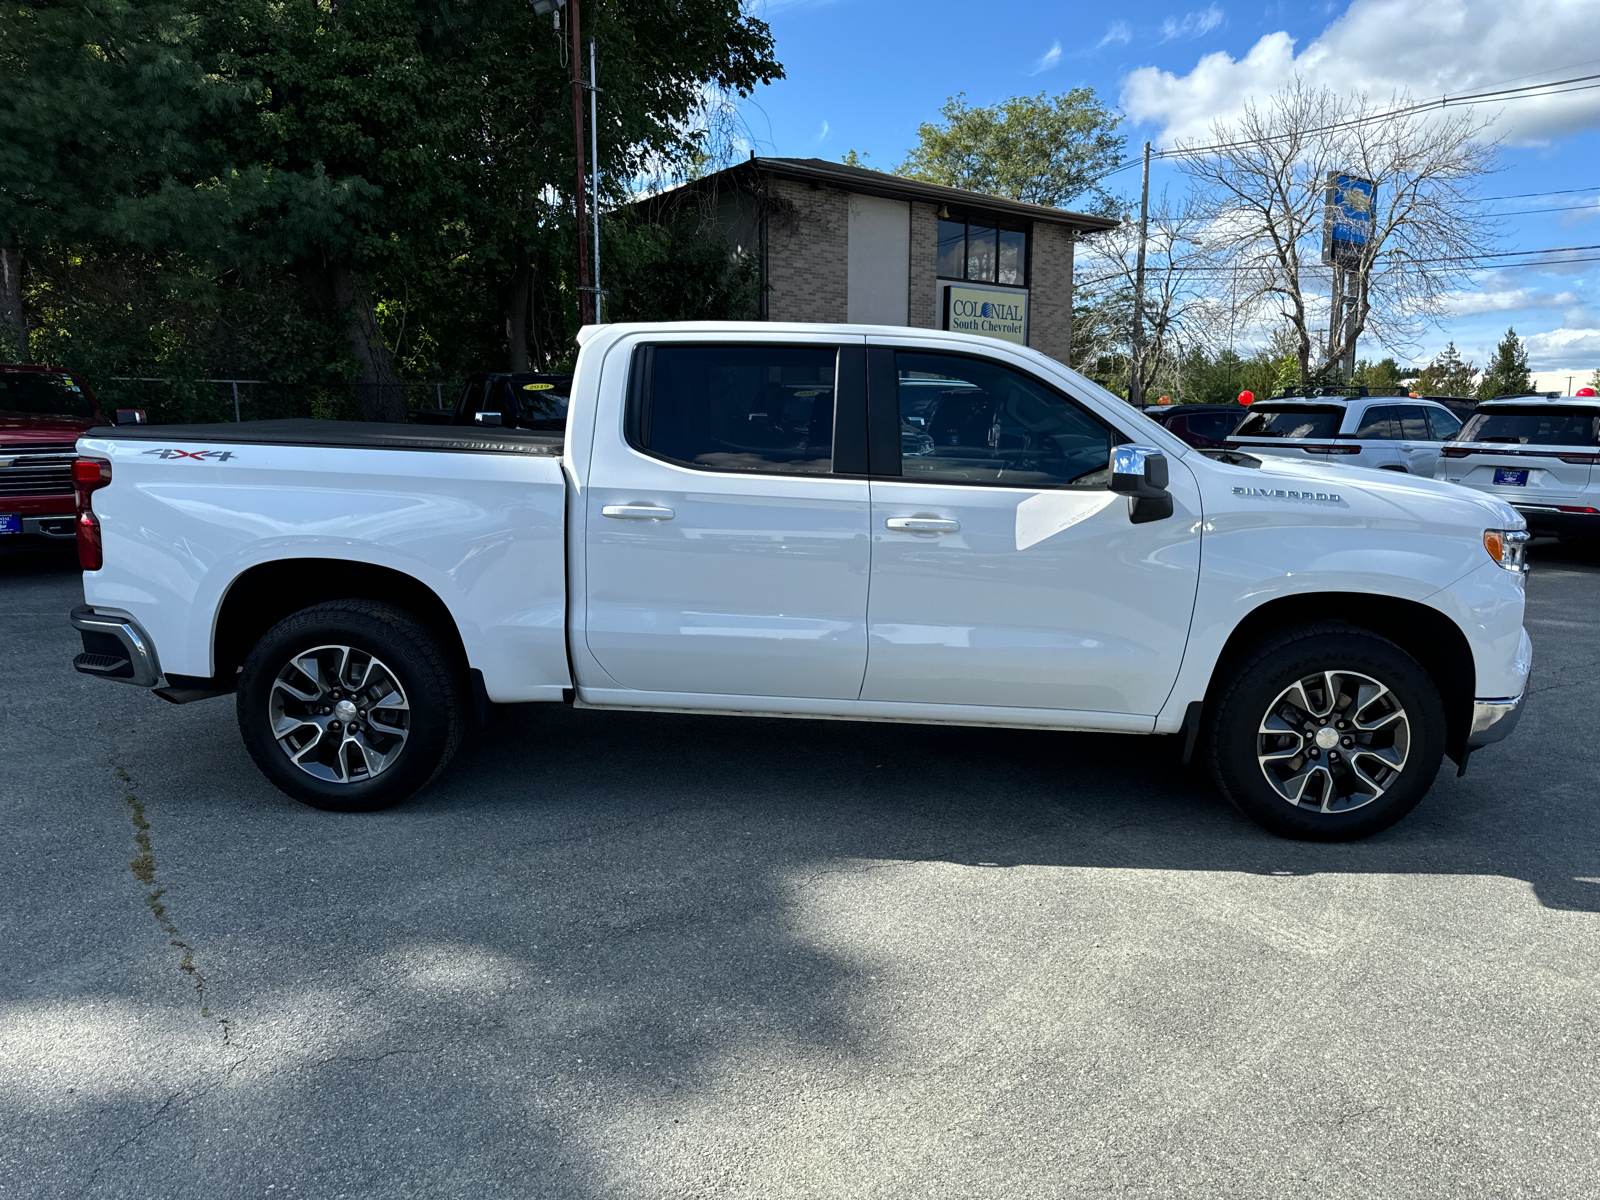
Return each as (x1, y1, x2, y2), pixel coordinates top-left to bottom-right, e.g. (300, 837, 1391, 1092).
(1122, 0, 1600, 144)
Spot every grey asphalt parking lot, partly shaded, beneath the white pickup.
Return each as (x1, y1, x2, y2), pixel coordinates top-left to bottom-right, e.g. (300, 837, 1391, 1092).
(0, 544, 1600, 1200)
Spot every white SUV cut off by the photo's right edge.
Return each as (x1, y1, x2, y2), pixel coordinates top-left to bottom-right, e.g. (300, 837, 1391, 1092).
(1434, 395, 1600, 534)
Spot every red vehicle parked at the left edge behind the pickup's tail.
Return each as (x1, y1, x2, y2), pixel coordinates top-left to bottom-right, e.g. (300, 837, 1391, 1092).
(0, 365, 144, 541)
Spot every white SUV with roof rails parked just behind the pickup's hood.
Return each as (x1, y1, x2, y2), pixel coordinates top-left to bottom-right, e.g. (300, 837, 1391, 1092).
(1227, 395, 1461, 475)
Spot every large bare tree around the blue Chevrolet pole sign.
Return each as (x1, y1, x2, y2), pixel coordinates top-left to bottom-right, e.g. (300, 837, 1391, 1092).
(1178, 78, 1494, 379)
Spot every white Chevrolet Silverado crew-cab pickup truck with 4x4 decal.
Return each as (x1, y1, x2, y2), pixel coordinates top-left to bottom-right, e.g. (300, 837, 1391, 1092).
(72, 323, 1531, 840)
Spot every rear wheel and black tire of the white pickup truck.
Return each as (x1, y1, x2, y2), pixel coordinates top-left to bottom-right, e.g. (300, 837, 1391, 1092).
(238, 600, 467, 813)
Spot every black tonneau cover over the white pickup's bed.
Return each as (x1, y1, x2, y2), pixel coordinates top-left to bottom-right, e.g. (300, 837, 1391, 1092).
(83, 418, 563, 458)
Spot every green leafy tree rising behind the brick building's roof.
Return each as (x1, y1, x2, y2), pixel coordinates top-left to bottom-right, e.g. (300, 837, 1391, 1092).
(896, 88, 1126, 211)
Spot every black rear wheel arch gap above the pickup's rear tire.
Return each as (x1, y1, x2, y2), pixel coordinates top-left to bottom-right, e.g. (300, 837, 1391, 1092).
(211, 558, 467, 690)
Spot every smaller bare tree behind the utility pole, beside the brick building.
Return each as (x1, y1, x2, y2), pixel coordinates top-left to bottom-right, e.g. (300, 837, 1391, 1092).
(1074, 195, 1227, 398)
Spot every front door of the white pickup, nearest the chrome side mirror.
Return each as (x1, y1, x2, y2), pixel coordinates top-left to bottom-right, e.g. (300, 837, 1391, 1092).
(861, 346, 1200, 717)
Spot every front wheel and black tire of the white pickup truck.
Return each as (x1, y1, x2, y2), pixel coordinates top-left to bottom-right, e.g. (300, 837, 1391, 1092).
(1203, 624, 1445, 842)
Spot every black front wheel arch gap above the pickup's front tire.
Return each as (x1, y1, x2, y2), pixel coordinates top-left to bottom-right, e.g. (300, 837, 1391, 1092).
(1205, 592, 1477, 763)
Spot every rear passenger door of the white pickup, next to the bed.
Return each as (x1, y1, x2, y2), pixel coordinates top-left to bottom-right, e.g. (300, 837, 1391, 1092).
(579, 336, 870, 699)
